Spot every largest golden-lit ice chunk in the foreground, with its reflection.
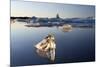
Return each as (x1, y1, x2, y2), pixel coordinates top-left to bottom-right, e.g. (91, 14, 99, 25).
(35, 34, 56, 61)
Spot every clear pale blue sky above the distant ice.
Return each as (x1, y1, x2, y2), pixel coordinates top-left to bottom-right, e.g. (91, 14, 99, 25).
(11, 0, 95, 18)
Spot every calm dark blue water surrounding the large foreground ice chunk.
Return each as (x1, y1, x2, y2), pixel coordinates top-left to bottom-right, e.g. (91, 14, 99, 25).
(10, 22, 95, 66)
